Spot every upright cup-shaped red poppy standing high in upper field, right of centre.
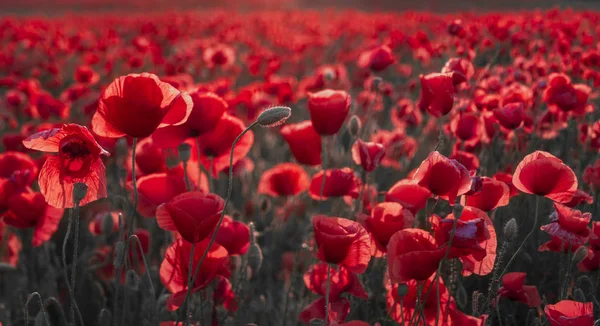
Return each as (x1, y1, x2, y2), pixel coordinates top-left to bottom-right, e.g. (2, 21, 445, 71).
(419, 73, 454, 117)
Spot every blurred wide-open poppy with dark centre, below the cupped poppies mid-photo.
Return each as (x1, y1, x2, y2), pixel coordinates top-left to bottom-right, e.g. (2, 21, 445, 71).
(258, 163, 309, 197)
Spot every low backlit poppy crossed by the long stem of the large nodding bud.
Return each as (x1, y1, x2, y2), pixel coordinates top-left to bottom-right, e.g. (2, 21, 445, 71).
(160, 239, 229, 311)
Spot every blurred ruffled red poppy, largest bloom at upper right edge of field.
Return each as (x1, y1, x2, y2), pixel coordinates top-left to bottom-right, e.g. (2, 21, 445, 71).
(542, 73, 591, 113)
